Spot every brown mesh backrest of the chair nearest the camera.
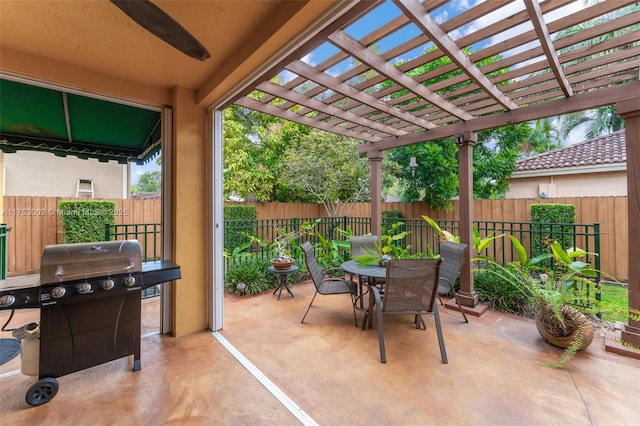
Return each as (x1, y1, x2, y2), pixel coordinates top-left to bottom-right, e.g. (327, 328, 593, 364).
(382, 259, 441, 312)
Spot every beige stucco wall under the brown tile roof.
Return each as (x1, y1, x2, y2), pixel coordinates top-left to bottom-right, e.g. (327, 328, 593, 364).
(505, 171, 627, 198)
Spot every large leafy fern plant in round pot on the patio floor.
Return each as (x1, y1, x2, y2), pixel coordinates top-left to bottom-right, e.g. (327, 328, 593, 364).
(478, 235, 615, 368)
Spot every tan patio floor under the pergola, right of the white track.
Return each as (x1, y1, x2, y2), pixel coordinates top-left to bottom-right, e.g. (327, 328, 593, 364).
(221, 282, 640, 425)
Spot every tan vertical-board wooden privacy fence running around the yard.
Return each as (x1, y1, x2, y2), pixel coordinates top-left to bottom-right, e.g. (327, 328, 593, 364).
(3, 196, 629, 279)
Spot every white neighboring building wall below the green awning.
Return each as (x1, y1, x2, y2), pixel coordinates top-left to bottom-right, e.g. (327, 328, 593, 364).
(0, 150, 131, 199)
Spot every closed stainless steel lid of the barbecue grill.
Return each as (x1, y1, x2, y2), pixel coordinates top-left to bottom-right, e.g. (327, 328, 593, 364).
(40, 240, 142, 285)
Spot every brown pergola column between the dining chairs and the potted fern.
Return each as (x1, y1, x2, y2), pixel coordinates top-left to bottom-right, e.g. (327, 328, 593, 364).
(455, 132, 479, 308)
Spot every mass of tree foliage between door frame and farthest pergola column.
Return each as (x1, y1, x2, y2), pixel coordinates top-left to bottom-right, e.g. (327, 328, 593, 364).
(224, 106, 369, 209)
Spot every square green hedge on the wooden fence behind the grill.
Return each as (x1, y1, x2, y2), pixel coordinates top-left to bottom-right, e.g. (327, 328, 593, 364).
(58, 201, 116, 244)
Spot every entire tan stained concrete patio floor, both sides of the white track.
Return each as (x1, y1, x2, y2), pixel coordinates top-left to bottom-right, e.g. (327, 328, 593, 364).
(0, 282, 640, 426)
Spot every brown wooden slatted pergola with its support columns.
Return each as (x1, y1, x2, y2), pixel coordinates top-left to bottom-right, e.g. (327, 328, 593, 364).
(218, 0, 640, 350)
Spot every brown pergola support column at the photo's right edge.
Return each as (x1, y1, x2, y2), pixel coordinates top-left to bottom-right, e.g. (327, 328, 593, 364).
(606, 97, 640, 358)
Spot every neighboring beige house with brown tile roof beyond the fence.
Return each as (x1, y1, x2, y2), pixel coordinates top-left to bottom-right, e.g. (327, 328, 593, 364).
(505, 130, 627, 198)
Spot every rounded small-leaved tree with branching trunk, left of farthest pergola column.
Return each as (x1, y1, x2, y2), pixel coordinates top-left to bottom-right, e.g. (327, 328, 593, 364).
(281, 129, 370, 217)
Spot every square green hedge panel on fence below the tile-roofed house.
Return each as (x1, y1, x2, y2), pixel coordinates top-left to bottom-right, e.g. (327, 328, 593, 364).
(529, 203, 576, 257)
